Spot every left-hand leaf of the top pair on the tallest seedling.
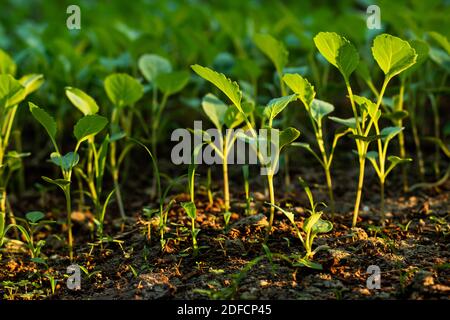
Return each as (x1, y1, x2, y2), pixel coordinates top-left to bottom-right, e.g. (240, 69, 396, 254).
(314, 32, 359, 80)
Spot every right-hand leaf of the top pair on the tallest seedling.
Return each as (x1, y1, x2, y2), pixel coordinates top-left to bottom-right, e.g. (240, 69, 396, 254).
(372, 33, 417, 79)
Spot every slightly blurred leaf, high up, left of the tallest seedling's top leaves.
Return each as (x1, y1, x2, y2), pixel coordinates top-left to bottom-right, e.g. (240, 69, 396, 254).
(253, 34, 289, 74)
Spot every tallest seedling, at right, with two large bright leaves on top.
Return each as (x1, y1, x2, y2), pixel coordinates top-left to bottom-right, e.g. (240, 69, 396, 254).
(314, 32, 417, 227)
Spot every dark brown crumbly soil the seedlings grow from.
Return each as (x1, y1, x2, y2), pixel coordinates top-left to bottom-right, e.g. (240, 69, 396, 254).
(0, 158, 450, 299)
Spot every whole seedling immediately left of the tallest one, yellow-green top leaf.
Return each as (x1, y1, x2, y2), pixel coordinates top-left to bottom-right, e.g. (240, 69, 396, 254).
(283, 74, 349, 215)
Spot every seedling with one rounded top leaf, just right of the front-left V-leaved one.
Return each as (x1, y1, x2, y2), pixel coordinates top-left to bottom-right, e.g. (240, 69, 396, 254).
(104, 73, 144, 219)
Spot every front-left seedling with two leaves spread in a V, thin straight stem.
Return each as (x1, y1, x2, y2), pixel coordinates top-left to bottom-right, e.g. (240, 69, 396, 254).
(29, 102, 108, 260)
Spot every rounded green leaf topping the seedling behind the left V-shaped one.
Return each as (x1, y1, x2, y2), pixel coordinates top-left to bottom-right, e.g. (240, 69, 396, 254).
(105, 73, 144, 108)
